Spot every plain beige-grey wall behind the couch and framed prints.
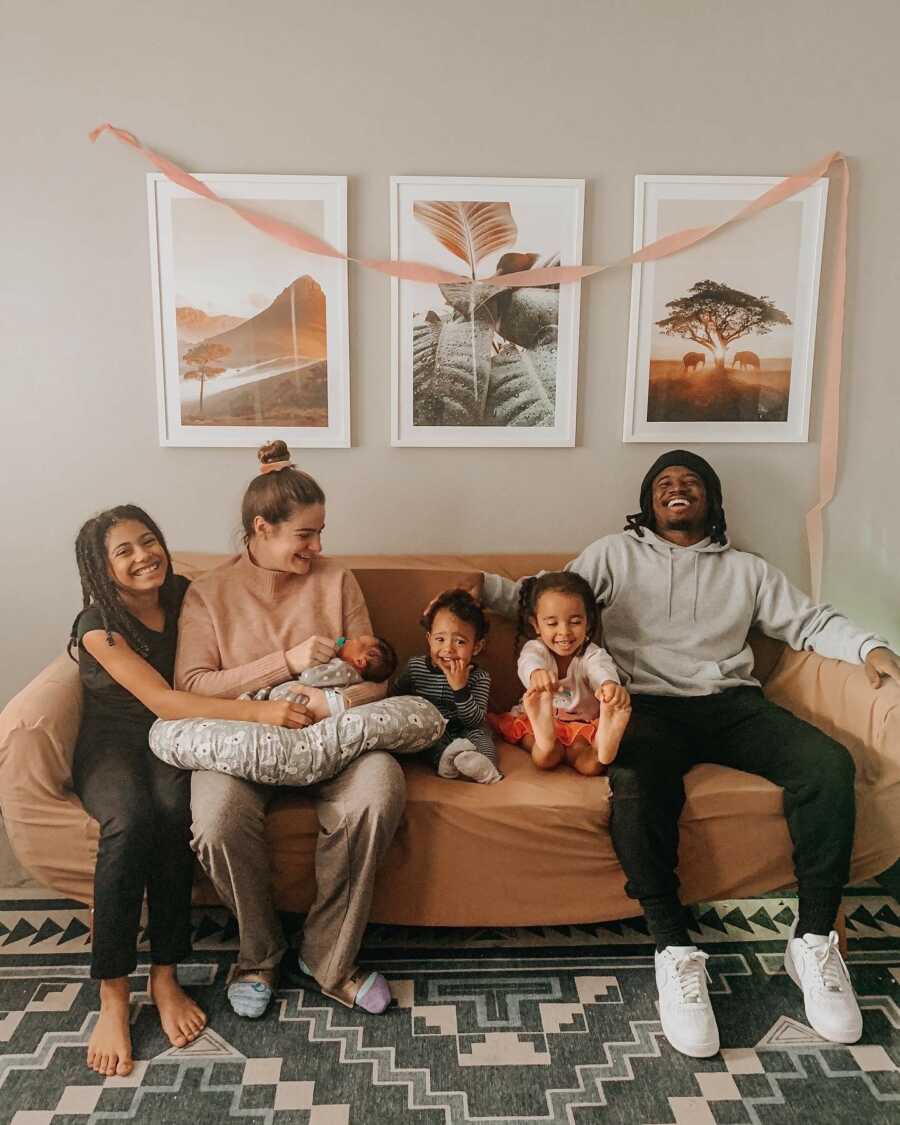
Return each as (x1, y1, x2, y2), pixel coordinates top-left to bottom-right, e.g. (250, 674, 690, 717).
(0, 0, 900, 703)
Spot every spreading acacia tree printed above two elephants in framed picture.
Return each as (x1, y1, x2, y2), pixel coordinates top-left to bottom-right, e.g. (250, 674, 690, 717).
(656, 280, 791, 375)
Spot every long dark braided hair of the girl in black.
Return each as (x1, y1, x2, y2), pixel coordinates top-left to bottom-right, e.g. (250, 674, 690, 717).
(65, 504, 174, 660)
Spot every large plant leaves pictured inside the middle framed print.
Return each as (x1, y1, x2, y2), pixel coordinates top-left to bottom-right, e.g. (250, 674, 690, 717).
(413, 200, 559, 426)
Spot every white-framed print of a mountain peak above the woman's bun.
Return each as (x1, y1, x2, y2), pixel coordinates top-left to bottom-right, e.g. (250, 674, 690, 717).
(147, 172, 351, 449)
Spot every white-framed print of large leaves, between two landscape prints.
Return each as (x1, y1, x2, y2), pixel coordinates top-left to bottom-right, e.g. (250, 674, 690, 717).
(390, 176, 584, 446)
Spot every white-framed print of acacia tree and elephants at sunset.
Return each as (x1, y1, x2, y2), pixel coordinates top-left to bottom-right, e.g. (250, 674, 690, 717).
(622, 176, 828, 444)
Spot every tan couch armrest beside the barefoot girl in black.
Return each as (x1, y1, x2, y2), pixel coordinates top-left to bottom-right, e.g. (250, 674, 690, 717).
(0, 655, 97, 902)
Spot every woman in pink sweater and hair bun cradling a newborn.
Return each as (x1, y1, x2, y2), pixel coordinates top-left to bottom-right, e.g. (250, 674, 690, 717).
(176, 441, 406, 1018)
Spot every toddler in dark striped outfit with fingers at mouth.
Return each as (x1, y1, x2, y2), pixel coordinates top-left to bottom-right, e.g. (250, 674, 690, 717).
(393, 590, 503, 785)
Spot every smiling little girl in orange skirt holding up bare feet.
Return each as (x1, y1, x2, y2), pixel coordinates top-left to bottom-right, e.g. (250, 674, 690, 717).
(488, 570, 631, 776)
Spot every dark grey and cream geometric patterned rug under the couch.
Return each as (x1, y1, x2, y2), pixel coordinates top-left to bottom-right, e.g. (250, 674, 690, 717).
(0, 885, 900, 1125)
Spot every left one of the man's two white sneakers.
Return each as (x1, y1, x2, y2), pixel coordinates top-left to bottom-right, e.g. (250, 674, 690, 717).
(655, 945, 719, 1059)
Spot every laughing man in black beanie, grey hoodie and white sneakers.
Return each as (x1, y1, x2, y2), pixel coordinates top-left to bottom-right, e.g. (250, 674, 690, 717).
(474, 449, 900, 1058)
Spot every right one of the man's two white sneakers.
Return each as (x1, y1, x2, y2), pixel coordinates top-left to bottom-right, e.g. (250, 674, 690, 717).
(784, 930, 863, 1043)
